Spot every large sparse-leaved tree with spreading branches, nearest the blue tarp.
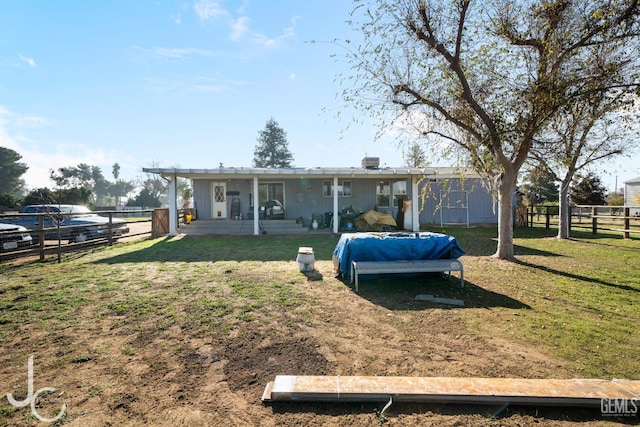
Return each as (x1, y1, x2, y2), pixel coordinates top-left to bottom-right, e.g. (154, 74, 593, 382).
(343, 0, 640, 259)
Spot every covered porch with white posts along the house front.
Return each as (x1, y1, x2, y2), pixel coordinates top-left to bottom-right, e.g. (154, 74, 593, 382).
(143, 167, 435, 235)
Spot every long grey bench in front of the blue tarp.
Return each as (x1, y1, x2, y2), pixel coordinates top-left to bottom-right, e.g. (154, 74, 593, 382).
(351, 259, 464, 292)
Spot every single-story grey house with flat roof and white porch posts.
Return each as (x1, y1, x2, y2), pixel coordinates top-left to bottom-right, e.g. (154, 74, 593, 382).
(143, 157, 497, 235)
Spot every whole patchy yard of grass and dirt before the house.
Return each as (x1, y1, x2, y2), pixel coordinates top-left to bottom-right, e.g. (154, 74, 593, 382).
(0, 228, 640, 426)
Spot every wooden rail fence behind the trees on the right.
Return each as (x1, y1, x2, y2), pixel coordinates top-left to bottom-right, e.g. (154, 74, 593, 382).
(526, 205, 640, 239)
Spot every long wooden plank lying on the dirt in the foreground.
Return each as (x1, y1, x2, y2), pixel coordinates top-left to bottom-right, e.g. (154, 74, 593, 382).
(262, 375, 640, 406)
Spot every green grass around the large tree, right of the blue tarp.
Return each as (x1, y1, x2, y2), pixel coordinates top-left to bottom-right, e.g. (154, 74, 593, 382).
(428, 224, 640, 379)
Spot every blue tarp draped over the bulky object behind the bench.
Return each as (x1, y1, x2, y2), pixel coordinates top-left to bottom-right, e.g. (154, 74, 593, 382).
(333, 232, 464, 279)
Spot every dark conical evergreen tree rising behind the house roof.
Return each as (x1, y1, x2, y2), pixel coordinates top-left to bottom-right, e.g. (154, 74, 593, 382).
(253, 118, 293, 168)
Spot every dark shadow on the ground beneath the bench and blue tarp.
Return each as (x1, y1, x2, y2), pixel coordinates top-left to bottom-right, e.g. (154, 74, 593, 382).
(338, 273, 531, 310)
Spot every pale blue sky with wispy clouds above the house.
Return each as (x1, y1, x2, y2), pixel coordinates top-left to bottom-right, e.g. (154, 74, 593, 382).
(0, 0, 640, 195)
